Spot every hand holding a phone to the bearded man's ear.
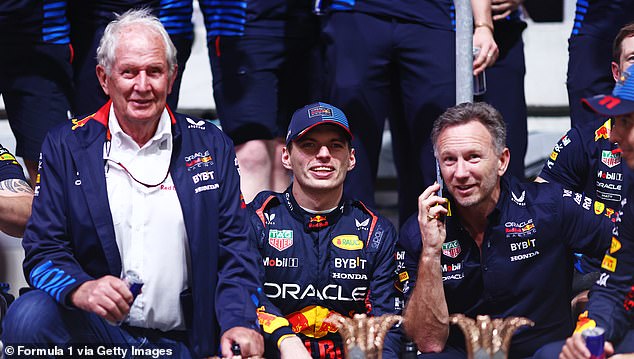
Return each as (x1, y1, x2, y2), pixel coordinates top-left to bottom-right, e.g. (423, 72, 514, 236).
(418, 183, 448, 255)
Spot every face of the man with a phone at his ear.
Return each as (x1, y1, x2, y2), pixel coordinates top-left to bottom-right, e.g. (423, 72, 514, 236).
(436, 120, 510, 213)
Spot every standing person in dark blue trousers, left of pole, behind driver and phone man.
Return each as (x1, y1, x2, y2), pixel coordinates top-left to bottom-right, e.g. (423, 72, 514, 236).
(323, 0, 498, 223)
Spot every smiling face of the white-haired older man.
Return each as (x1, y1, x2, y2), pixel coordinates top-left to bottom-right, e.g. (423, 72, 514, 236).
(97, 25, 175, 132)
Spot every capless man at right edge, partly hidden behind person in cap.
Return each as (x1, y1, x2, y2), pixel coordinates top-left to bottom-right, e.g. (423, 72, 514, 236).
(537, 24, 634, 292)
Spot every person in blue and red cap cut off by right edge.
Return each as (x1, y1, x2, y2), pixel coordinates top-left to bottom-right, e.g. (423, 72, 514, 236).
(538, 70, 634, 358)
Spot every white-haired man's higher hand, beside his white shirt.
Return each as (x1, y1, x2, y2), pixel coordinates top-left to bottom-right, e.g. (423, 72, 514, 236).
(70, 275, 134, 322)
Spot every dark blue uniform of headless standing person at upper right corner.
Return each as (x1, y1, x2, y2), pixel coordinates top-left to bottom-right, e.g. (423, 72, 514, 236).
(566, 0, 634, 126)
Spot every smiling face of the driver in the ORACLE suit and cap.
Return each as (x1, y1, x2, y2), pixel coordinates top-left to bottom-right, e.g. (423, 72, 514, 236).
(282, 125, 355, 206)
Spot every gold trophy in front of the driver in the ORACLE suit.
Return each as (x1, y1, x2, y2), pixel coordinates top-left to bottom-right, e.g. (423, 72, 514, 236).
(326, 314, 403, 359)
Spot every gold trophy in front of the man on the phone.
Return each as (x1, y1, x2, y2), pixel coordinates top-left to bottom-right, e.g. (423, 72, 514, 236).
(449, 314, 535, 359)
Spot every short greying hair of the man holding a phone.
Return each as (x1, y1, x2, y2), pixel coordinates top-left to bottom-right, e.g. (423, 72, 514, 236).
(431, 102, 506, 155)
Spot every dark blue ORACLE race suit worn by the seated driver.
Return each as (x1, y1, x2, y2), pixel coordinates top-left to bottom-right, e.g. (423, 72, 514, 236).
(249, 188, 403, 359)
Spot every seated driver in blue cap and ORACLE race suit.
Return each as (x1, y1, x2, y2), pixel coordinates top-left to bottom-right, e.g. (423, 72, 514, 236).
(249, 102, 403, 359)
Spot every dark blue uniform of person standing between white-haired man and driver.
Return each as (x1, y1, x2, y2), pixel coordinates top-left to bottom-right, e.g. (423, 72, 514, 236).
(205, 0, 321, 145)
